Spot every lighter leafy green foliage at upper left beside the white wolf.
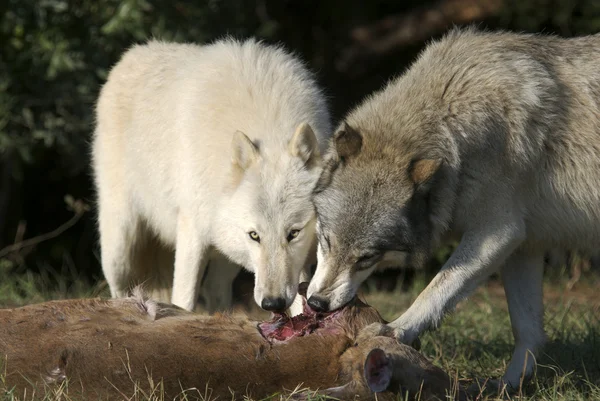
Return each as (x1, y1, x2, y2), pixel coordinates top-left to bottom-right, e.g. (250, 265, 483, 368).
(0, 0, 258, 178)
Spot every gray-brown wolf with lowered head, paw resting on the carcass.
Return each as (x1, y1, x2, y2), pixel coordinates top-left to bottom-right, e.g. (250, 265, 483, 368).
(308, 29, 600, 386)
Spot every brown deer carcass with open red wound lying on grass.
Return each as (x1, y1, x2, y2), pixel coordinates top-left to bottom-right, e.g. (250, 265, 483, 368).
(0, 286, 464, 400)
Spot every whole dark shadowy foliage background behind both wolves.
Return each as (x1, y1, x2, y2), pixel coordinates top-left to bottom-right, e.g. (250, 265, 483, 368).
(0, 0, 600, 282)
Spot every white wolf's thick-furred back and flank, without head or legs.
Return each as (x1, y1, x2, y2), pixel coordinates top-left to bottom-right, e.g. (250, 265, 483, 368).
(93, 39, 330, 243)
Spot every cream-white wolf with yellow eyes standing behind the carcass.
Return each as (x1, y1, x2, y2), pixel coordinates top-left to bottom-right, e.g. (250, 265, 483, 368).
(93, 39, 330, 309)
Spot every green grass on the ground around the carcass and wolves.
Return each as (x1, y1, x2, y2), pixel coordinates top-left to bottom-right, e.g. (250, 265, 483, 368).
(0, 265, 600, 401)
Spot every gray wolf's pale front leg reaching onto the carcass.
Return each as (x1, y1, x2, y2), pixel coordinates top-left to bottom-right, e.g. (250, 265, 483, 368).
(371, 215, 525, 344)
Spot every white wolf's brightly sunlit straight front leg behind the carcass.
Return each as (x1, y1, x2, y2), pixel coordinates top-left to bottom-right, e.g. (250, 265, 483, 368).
(171, 213, 210, 311)
